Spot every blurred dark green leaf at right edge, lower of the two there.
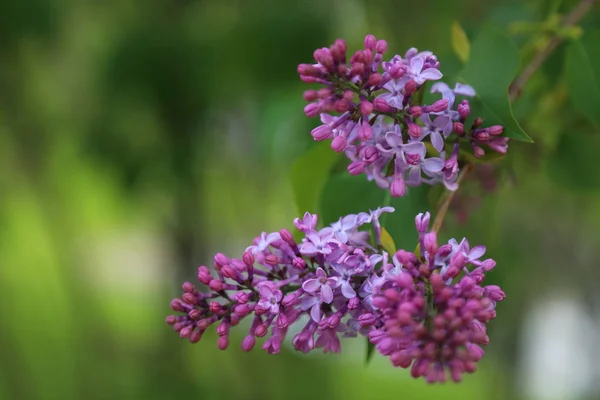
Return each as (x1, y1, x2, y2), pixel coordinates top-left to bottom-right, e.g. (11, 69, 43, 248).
(547, 132, 600, 192)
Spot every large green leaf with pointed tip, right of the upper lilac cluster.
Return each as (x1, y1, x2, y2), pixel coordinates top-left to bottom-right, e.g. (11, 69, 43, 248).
(459, 28, 533, 142)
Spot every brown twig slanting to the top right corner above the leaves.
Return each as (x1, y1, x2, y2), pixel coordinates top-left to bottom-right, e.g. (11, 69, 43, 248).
(509, 0, 596, 101)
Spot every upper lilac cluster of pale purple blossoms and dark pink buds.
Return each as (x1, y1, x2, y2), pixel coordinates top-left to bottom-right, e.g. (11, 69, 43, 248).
(298, 35, 508, 197)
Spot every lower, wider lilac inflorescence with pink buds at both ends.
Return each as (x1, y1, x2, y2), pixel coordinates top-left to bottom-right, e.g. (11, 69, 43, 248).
(166, 207, 504, 382)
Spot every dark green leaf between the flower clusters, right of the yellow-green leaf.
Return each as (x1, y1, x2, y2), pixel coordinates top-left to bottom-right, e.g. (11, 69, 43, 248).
(319, 172, 386, 225)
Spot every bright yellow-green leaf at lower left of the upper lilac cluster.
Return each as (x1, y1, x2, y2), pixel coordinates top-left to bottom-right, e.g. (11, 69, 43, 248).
(290, 142, 340, 215)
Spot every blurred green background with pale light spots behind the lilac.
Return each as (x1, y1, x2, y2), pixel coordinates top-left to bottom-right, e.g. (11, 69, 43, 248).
(0, 0, 600, 400)
